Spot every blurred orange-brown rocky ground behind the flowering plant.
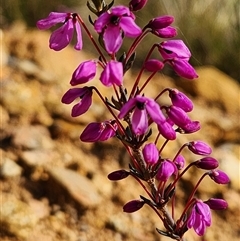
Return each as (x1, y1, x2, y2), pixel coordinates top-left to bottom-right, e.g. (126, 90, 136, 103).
(0, 24, 240, 241)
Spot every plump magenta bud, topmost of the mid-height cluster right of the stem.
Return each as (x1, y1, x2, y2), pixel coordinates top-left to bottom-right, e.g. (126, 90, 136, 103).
(169, 89, 193, 112)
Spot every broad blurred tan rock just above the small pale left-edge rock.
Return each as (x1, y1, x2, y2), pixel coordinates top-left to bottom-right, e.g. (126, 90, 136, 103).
(13, 125, 54, 149)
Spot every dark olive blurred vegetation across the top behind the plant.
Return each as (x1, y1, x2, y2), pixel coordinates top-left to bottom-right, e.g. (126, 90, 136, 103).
(0, 0, 240, 81)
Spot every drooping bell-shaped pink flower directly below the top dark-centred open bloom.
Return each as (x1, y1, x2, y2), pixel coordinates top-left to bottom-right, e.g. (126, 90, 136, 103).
(100, 60, 123, 86)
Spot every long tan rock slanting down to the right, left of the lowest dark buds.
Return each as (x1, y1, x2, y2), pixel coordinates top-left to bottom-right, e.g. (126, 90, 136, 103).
(48, 167, 101, 208)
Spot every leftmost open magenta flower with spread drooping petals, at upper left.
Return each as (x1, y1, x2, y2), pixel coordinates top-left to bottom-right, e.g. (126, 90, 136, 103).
(37, 12, 83, 51)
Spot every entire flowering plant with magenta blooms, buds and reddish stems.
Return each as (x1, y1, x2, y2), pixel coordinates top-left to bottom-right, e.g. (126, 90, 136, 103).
(37, 0, 229, 240)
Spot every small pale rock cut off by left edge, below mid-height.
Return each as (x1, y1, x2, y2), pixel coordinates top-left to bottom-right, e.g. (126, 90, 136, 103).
(0, 158, 22, 178)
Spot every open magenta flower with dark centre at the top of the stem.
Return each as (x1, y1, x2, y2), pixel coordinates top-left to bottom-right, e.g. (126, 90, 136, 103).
(94, 6, 142, 54)
